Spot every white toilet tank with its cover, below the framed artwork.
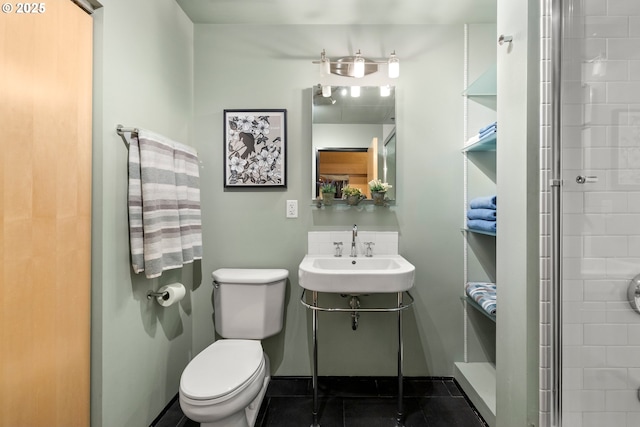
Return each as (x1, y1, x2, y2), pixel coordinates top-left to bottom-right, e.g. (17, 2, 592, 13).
(212, 268, 289, 340)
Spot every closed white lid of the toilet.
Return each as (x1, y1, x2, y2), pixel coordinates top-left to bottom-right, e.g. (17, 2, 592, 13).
(180, 339, 263, 400)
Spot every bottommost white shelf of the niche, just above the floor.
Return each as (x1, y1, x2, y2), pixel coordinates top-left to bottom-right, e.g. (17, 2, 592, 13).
(453, 362, 496, 426)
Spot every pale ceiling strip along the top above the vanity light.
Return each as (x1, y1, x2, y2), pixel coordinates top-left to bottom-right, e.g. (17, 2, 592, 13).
(176, 0, 496, 25)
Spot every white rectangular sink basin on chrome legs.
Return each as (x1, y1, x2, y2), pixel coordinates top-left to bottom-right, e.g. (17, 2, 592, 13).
(298, 255, 416, 294)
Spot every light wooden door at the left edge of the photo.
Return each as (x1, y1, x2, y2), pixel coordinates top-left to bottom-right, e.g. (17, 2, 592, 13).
(0, 0, 92, 427)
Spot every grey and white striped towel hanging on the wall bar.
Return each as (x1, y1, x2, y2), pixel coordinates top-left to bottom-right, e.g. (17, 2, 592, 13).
(129, 130, 202, 278)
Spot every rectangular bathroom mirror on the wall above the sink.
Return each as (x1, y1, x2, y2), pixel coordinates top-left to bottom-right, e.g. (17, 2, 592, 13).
(311, 85, 397, 200)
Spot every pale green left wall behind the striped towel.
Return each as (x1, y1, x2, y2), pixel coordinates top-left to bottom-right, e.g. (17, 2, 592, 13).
(91, 0, 194, 427)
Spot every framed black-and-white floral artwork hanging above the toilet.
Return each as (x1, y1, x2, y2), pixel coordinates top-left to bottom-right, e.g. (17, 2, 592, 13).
(224, 110, 287, 188)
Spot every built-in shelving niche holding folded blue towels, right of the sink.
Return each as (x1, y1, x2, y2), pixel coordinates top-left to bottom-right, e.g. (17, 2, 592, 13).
(454, 26, 498, 426)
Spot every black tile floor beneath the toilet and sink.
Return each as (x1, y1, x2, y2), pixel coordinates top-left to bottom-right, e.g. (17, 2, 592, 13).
(152, 377, 487, 427)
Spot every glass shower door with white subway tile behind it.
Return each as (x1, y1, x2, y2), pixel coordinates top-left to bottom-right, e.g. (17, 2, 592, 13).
(556, 0, 640, 427)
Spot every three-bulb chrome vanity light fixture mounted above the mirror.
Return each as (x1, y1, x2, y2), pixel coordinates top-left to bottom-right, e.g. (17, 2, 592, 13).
(312, 49, 400, 79)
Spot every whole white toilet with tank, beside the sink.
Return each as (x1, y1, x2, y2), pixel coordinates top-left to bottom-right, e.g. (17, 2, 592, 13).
(180, 268, 289, 427)
